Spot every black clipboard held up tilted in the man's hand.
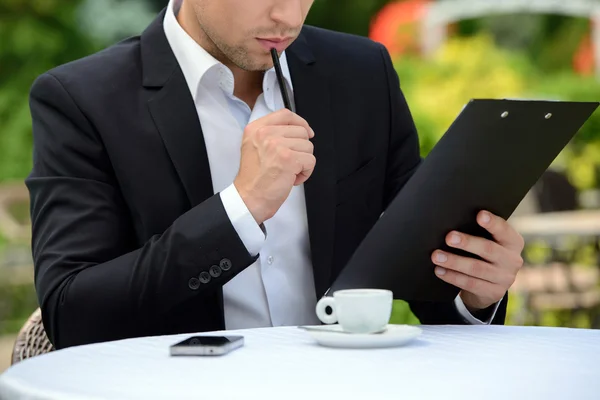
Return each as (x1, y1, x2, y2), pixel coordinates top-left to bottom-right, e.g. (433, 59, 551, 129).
(327, 99, 600, 301)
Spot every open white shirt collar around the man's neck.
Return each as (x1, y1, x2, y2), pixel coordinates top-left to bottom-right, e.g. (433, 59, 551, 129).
(163, 0, 293, 110)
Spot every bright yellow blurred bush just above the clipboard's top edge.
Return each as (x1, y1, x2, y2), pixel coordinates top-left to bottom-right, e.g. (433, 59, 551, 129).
(395, 35, 530, 156)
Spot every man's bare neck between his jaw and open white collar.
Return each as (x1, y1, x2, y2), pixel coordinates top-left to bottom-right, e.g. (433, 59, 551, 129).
(177, 1, 264, 108)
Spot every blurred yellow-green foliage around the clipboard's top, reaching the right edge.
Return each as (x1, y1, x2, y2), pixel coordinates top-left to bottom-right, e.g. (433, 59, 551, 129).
(395, 33, 600, 190)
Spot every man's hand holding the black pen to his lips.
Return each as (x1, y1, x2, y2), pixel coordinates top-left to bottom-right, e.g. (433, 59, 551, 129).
(233, 109, 316, 224)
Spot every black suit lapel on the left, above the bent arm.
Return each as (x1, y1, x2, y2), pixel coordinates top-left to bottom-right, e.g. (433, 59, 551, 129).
(141, 11, 214, 207)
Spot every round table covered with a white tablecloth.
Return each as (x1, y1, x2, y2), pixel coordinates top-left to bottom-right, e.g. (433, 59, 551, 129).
(0, 326, 600, 400)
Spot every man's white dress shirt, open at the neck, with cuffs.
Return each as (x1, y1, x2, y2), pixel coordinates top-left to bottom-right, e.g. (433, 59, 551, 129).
(164, 0, 495, 329)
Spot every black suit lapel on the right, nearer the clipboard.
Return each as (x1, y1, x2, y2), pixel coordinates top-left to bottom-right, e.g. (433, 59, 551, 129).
(286, 35, 335, 298)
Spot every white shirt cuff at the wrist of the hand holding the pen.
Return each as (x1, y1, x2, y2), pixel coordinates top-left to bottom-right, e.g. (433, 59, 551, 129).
(220, 183, 266, 257)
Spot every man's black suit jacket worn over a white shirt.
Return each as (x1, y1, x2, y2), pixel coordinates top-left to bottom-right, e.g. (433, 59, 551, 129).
(26, 11, 505, 348)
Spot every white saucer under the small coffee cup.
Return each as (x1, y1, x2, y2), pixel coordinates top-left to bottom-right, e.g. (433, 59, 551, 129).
(306, 324, 423, 349)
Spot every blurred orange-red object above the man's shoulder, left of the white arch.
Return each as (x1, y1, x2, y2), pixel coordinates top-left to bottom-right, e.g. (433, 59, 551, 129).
(369, 0, 431, 55)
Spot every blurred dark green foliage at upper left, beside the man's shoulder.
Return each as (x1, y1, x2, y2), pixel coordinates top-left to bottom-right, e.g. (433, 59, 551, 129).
(0, 0, 95, 181)
